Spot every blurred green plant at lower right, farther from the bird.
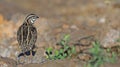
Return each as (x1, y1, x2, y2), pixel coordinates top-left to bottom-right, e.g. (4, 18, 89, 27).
(85, 41, 116, 67)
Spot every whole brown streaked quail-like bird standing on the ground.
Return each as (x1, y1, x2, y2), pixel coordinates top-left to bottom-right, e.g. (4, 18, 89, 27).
(17, 14, 39, 57)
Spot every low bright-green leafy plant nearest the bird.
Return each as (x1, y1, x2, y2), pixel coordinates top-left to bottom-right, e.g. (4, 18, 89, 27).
(46, 35, 76, 60)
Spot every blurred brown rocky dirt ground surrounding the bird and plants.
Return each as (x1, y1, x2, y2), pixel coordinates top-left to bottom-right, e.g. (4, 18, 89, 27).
(0, 0, 120, 67)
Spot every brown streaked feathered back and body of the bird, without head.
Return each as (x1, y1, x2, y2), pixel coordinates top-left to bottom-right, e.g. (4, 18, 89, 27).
(17, 23, 37, 53)
